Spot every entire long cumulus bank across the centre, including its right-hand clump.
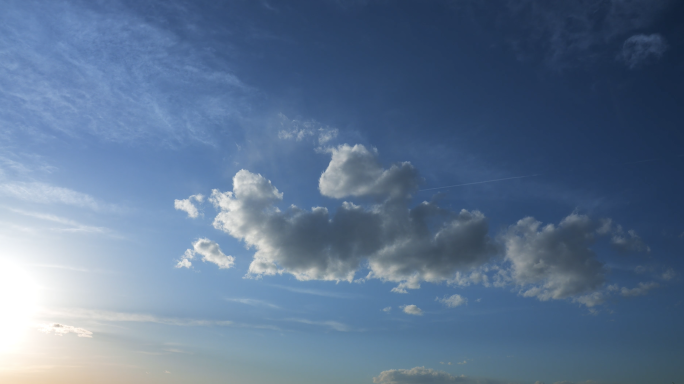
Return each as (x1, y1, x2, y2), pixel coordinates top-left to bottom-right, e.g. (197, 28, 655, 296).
(190, 144, 653, 308)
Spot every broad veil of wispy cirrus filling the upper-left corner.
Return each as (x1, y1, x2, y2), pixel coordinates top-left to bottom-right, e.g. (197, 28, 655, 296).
(0, 0, 252, 146)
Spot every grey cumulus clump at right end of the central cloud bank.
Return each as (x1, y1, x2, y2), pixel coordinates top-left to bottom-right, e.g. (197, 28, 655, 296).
(502, 214, 605, 300)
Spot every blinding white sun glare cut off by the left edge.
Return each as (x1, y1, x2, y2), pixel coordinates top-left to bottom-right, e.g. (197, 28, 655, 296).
(0, 260, 37, 353)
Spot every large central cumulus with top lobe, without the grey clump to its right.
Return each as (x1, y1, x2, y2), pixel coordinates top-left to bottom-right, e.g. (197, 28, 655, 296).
(209, 145, 496, 292)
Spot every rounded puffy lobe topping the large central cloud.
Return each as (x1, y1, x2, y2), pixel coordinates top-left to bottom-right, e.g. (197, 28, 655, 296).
(318, 144, 420, 199)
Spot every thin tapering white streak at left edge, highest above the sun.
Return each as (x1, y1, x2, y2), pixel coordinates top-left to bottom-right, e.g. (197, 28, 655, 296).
(0, 182, 118, 211)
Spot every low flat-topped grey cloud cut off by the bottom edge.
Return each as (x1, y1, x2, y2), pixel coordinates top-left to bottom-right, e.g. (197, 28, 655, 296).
(373, 367, 498, 384)
